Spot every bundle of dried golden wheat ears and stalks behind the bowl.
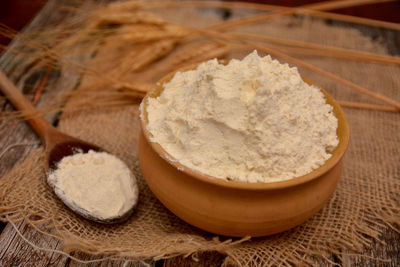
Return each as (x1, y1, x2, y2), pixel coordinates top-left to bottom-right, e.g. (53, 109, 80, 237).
(0, 1, 400, 113)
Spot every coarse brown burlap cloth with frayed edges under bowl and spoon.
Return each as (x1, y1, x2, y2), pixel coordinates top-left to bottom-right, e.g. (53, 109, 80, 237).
(0, 4, 400, 266)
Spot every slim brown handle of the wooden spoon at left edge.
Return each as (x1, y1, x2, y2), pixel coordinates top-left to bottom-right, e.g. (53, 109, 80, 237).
(0, 70, 54, 142)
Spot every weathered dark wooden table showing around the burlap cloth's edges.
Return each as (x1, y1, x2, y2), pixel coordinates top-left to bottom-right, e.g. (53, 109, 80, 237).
(0, 0, 400, 266)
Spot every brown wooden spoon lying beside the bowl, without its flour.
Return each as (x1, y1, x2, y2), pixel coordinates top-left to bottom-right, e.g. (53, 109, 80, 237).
(0, 70, 138, 224)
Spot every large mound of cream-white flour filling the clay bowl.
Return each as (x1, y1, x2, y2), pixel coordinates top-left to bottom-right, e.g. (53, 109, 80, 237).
(147, 51, 338, 182)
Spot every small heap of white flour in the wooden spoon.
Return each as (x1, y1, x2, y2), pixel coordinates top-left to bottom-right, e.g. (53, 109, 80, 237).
(48, 150, 138, 219)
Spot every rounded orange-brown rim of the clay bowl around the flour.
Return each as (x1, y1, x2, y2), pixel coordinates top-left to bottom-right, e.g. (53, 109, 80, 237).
(140, 68, 350, 190)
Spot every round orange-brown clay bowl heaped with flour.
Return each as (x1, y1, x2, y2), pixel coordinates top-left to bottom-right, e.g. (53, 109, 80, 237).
(139, 70, 349, 237)
